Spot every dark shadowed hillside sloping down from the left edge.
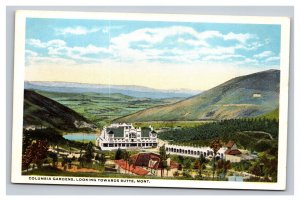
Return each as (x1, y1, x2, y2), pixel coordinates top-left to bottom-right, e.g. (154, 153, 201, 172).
(23, 89, 94, 131)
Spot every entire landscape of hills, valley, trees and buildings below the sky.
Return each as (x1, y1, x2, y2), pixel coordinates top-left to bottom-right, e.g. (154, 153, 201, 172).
(22, 70, 280, 182)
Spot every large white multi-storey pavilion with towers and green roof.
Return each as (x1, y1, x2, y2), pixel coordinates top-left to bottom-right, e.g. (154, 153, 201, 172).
(96, 123, 157, 150)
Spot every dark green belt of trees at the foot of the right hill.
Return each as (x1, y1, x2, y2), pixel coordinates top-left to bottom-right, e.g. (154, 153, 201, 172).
(159, 118, 278, 151)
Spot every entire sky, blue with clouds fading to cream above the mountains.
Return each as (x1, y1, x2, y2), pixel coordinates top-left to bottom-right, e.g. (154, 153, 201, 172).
(25, 18, 280, 90)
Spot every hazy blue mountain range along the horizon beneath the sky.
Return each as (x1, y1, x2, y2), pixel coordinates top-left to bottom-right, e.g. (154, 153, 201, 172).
(25, 81, 200, 99)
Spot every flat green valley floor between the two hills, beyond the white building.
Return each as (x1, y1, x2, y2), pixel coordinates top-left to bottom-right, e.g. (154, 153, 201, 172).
(37, 91, 178, 127)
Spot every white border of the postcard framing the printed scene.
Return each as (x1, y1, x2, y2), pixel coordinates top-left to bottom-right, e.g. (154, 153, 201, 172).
(11, 11, 290, 190)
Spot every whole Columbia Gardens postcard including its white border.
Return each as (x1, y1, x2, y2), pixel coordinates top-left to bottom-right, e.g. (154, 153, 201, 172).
(11, 10, 290, 190)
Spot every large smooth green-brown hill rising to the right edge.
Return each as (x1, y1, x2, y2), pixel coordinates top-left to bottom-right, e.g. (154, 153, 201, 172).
(115, 70, 280, 122)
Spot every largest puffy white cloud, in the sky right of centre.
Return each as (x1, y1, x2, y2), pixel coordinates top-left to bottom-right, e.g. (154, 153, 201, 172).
(110, 26, 260, 63)
